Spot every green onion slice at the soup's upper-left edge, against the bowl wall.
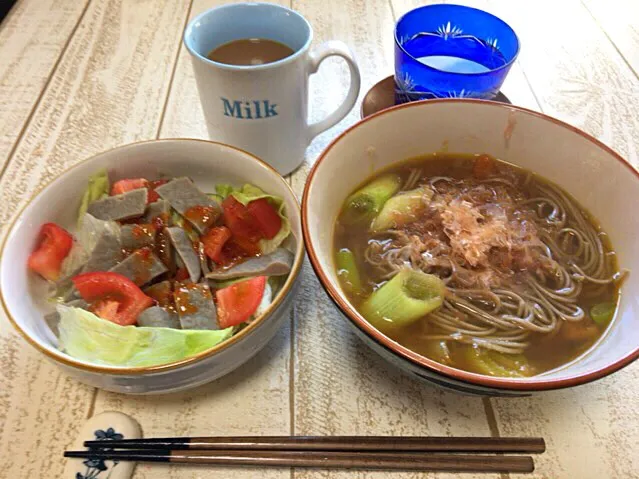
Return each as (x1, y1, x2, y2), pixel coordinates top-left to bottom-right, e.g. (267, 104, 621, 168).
(343, 174, 401, 223)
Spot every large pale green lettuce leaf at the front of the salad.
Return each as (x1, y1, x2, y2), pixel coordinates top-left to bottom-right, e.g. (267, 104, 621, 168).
(57, 305, 233, 367)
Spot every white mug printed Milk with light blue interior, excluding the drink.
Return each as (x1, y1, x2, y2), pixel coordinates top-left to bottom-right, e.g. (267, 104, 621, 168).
(184, 3, 360, 175)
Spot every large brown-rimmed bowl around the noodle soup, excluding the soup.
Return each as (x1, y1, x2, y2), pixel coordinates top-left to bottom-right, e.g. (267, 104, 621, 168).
(302, 99, 639, 395)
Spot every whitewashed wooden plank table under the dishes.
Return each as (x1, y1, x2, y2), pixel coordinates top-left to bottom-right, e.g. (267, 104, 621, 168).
(0, 0, 639, 479)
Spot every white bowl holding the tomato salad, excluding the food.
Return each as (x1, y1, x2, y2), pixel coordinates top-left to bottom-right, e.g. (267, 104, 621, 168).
(0, 139, 304, 394)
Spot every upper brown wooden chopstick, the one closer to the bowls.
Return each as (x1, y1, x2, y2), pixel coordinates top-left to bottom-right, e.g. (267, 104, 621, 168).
(84, 436, 546, 453)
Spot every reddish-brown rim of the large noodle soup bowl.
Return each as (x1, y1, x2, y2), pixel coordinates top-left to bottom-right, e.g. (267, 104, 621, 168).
(302, 98, 639, 391)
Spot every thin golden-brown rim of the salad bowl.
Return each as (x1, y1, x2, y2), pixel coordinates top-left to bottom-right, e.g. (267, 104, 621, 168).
(0, 138, 304, 376)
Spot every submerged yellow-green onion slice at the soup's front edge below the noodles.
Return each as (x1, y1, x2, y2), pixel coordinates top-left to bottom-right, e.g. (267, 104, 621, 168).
(464, 346, 533, 378)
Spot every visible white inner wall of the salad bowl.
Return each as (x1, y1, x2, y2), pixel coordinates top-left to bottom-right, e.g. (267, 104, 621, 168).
(0, 140, 303, 370)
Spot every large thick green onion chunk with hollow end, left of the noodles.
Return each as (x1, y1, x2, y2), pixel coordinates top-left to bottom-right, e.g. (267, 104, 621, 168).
(361, 269, 446, 331)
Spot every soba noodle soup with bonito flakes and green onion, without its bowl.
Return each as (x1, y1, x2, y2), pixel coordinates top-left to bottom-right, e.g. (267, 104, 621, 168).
(335, 154, 624, 377)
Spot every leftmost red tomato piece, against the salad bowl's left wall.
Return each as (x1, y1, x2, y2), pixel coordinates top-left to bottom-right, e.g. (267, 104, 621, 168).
(27, 223, 73, 281)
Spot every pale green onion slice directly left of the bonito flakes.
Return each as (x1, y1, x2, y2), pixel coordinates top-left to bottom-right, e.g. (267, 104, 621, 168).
(371, 185, 433, 231)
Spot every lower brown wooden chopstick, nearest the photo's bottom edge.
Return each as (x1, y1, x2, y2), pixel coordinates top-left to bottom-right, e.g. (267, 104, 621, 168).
(64, 448, 534, 473)
